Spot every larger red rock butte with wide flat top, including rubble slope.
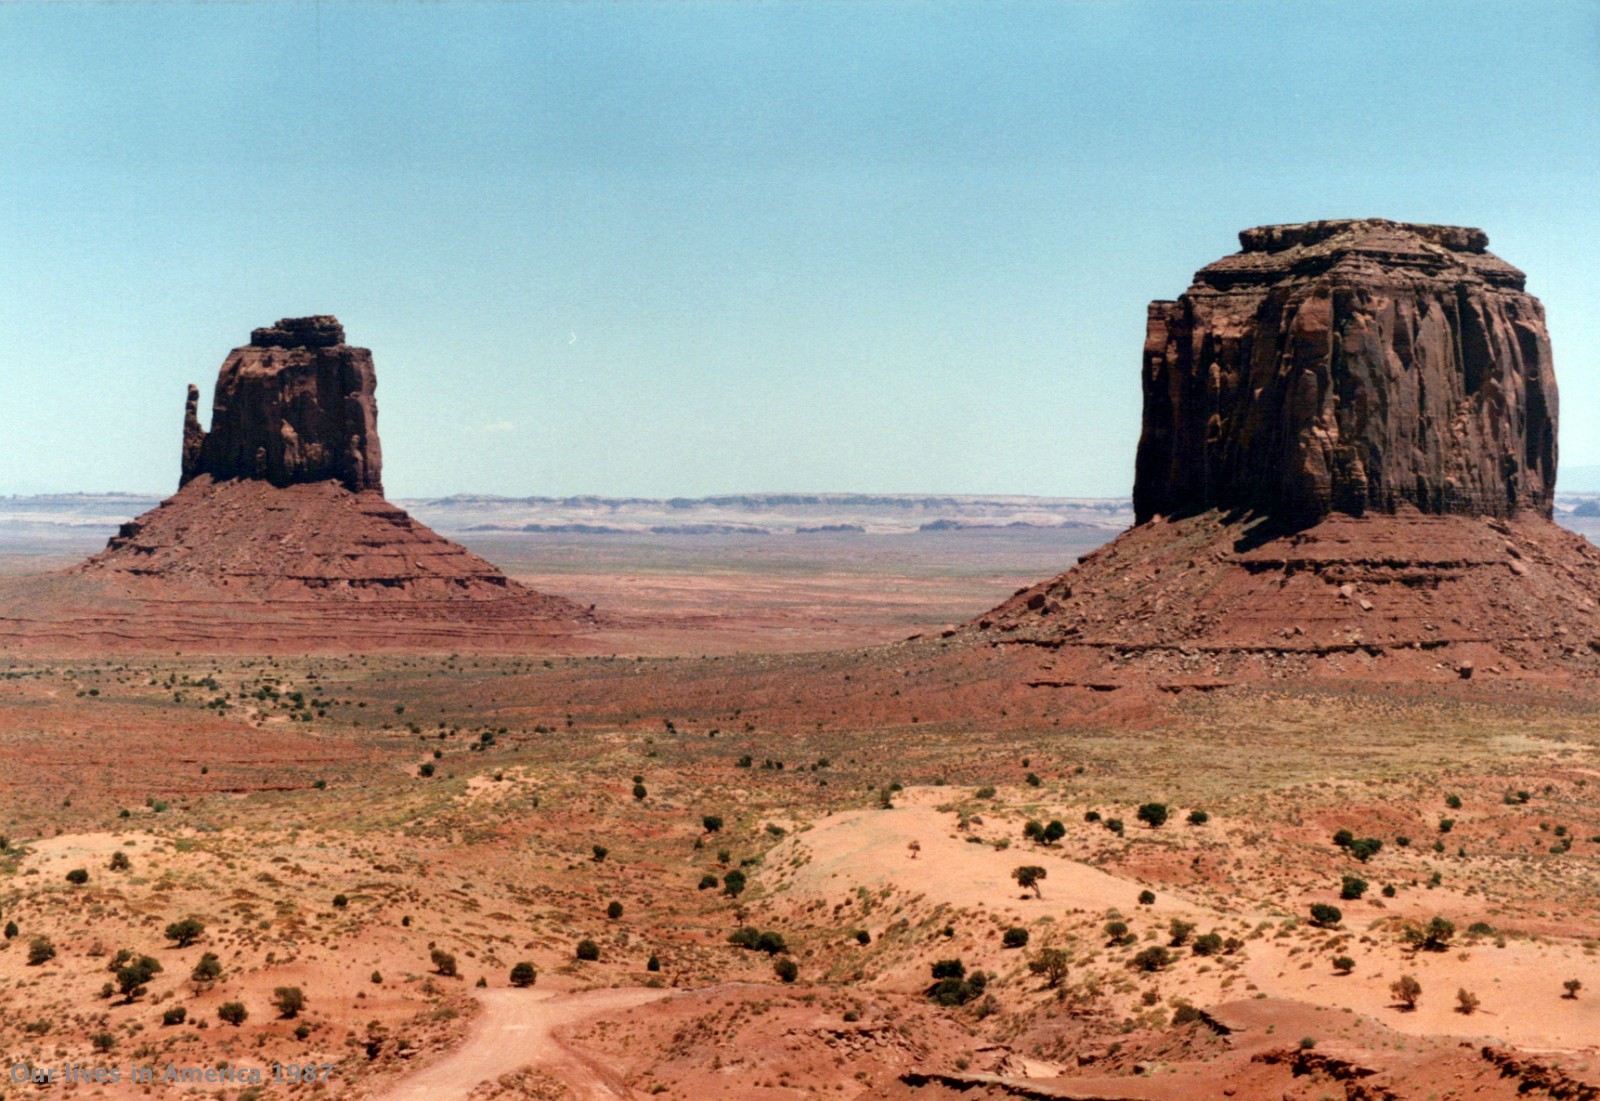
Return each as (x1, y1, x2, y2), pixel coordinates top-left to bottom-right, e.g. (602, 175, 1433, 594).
(970, 218, 1600, 690)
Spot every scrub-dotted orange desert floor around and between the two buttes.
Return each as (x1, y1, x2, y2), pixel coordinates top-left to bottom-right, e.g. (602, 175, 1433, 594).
(0, 534, 1600, 1101)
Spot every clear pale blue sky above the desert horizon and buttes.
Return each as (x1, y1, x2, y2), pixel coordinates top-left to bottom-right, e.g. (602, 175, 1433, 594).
(0, 0, 1600, 496)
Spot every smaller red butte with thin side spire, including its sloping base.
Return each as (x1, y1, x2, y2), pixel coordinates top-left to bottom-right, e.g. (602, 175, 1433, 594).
(0, 317, 594, 651)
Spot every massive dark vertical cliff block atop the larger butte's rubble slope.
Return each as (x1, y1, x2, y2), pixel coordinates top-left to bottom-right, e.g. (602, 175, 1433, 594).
(1133, 219, 1557, 525)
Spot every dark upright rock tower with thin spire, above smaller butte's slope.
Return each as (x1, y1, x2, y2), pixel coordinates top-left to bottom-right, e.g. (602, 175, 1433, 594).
(179, 315, 382, 493)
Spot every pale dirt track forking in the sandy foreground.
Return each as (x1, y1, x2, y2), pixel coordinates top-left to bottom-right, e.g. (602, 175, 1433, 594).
(376, 987, 670, 1101)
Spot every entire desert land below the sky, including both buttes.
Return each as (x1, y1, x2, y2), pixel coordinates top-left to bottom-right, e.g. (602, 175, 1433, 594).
(0, 219, 1600, 1101)
